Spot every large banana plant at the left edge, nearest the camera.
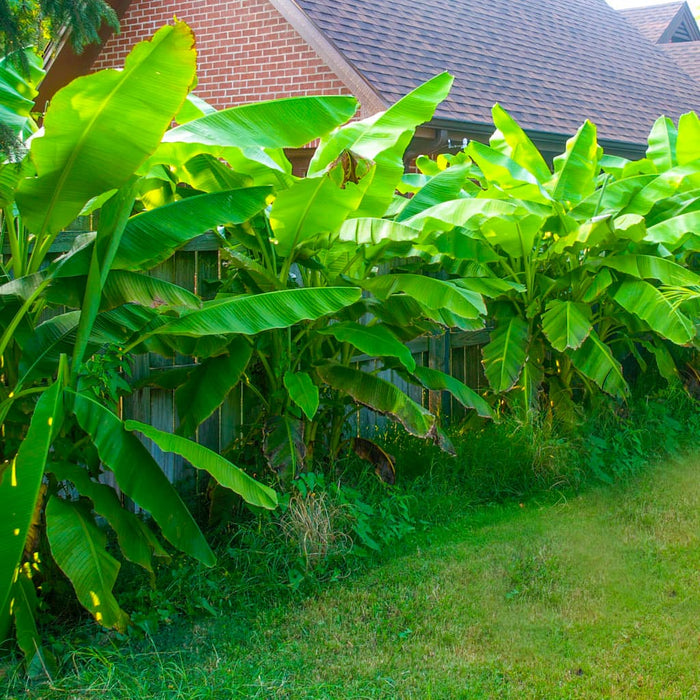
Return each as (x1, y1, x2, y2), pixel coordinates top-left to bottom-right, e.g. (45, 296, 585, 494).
(0, 22, 372, 672)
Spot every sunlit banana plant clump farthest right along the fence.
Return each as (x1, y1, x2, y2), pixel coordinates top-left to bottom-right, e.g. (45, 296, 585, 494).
(403, 105, 700, 415)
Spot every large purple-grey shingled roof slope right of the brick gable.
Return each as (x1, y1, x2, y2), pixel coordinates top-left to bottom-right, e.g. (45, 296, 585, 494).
(292, 0, 700, 144)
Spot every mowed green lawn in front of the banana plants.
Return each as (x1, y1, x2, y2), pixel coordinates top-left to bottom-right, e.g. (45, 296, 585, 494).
(5, 455, 700, 700)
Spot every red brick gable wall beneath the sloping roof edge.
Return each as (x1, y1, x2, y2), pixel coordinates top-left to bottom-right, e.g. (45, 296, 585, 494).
(93, 0, 350, 109)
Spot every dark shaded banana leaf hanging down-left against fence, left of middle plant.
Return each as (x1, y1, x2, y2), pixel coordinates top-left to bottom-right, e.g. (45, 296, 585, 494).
(175, 336, 253, 436)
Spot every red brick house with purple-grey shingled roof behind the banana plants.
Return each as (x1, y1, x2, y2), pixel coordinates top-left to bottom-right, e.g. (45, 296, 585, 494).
(39, 0, 700, 157)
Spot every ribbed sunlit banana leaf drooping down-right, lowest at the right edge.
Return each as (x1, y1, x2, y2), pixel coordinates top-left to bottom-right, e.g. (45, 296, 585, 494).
(613, 280, 695, 345)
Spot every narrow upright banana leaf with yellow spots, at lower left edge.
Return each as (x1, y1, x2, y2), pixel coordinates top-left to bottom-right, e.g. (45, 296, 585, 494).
(0, 373, 64, 639)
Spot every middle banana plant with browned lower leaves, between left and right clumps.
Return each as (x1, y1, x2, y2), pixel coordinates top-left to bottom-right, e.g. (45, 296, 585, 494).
(131, 74, 490, 484)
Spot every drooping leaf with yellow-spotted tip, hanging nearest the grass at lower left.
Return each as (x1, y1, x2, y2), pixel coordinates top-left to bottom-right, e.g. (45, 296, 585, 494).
(46, 496, 129, 632)
